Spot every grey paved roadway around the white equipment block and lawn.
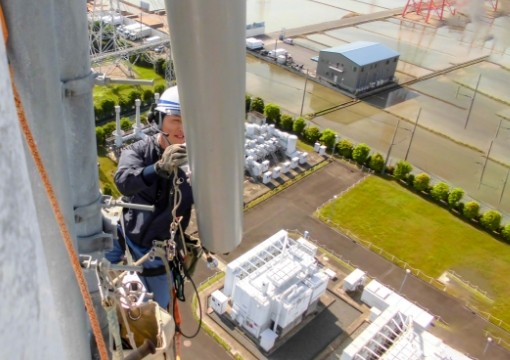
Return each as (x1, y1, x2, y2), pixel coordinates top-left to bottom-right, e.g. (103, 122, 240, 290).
(177, 161, 510, 360)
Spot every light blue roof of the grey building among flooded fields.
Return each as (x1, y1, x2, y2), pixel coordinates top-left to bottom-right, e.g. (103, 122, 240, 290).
(321, 41, 400, 66)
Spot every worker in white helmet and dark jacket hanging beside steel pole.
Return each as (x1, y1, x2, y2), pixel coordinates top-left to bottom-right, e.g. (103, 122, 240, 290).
(106, 86, 200, 309)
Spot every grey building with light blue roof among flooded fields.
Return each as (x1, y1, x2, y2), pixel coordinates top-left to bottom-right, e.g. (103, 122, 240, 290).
(317, 41, 400, 94)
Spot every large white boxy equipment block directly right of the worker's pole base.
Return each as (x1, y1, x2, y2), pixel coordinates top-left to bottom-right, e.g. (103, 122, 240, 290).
(210, 230, 329, 351)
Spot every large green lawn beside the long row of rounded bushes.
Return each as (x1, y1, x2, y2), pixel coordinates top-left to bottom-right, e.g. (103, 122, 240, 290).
(320, 176, 510, 324)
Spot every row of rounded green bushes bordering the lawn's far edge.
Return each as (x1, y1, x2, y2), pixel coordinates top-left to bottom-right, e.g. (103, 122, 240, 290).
(246, 95, 510, 243)
